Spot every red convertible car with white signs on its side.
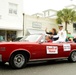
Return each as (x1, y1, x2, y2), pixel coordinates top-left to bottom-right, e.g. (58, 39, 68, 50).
(0, 34, 76, 69)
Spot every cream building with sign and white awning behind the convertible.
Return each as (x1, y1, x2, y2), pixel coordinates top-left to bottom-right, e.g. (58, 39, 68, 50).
(24, 15, 58, 36)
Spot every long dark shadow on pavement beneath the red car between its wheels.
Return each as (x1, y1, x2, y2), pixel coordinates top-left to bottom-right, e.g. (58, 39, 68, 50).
(26, 60, 70, 68)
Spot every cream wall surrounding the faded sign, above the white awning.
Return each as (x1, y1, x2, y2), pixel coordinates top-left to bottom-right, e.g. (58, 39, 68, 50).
(24, 15, 58, 34)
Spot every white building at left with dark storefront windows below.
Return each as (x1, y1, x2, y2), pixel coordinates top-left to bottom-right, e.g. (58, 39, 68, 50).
(0, 0, 23, 40)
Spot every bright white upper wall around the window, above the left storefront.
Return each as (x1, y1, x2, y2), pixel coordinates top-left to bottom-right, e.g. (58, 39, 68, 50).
(0, 0, 23, 30)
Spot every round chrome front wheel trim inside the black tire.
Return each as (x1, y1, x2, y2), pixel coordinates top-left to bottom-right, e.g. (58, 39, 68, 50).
(14, 54, 25, 68)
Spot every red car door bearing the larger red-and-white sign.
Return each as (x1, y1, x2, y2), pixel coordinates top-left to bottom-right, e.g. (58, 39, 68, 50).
(42, 43, 64, 58)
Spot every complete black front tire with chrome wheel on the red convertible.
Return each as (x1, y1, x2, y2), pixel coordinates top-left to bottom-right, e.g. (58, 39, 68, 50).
(9, 52, 27, 69)
